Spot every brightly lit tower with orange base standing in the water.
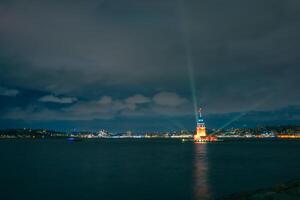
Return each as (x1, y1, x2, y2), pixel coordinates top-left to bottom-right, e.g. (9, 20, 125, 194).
(194, 108, 218, 142)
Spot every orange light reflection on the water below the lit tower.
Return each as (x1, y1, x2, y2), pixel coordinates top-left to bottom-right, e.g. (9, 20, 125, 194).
(194, 143, 211, 200)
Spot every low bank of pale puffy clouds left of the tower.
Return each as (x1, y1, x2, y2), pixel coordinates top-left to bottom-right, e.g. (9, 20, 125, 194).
(3, 92, 193, 120)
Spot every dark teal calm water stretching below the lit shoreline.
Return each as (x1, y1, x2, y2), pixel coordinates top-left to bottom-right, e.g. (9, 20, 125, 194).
(0, 139, 300, 200)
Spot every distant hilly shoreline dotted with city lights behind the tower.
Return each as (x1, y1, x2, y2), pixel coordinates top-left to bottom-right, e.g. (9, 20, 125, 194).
(0, 125, 300, 140)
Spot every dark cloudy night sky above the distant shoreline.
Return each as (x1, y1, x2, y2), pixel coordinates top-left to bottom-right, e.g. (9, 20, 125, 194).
(0, 0, 300, 130)
